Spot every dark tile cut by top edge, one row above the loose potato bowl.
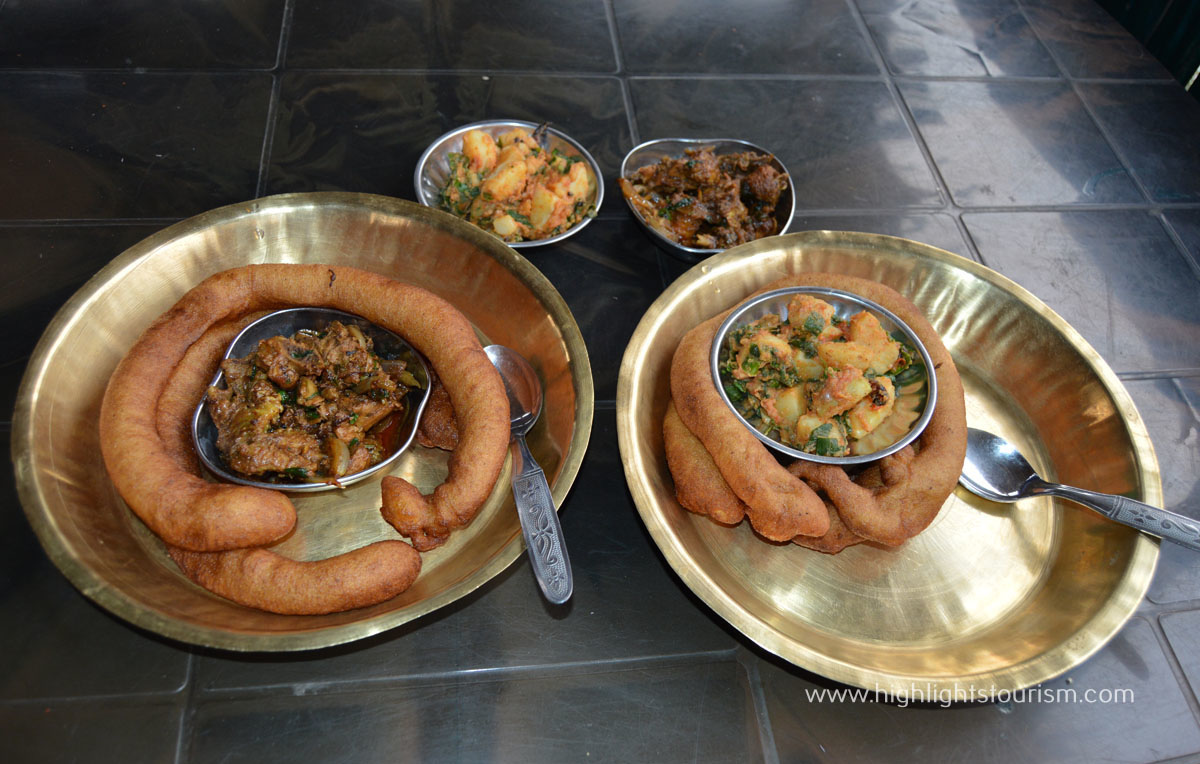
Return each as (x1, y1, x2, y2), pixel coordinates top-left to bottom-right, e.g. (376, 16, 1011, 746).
(287, 0, 617, 72)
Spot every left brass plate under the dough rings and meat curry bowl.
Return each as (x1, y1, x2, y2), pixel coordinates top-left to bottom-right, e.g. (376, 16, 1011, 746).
(12, 193, 594, 650)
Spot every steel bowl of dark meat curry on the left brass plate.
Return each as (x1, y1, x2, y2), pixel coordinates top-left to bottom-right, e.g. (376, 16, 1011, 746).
(192, 307, 431, 492)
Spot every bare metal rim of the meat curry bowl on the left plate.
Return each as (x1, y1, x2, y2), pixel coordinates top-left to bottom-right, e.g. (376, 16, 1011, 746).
(192, 308, 430, 493)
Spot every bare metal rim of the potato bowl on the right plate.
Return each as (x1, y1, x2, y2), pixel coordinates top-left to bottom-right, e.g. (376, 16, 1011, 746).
(709, 287, 937, 465)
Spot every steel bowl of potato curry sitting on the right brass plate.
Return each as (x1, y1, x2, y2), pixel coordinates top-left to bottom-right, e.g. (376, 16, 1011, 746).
(709, 287, 937, 465)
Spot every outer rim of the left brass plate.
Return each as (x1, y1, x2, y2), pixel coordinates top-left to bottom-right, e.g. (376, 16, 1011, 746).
(10, 192, 595, 652)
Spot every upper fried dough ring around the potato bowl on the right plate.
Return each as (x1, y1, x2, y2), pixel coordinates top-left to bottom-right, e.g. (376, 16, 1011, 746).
(665, 273, 966, 552)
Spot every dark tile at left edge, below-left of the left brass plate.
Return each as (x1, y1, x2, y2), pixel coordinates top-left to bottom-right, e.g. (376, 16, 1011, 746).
(0, 455, 190, 700)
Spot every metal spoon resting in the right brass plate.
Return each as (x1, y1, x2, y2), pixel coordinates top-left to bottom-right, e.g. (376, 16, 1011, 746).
(959, 428, 1200, 552)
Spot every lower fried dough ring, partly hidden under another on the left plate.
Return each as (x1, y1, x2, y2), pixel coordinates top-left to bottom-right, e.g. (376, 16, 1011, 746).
(157, 313, 421, 615)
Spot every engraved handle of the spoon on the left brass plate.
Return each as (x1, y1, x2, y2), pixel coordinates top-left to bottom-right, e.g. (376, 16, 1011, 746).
(512, 435, 575, 604)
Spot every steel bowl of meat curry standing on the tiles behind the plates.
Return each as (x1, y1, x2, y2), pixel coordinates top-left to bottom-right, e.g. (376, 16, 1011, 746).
(619, 138, 796, 263)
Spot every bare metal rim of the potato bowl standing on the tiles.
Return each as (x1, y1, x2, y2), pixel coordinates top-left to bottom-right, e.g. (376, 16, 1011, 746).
(413, 120, 604, 249)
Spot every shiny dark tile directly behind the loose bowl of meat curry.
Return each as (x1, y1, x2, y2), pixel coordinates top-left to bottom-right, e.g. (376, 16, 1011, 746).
(630, 78, 942, 210)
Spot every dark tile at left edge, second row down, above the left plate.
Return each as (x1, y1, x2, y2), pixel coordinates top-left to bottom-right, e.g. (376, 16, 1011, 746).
(0, 73, 271, 219)
